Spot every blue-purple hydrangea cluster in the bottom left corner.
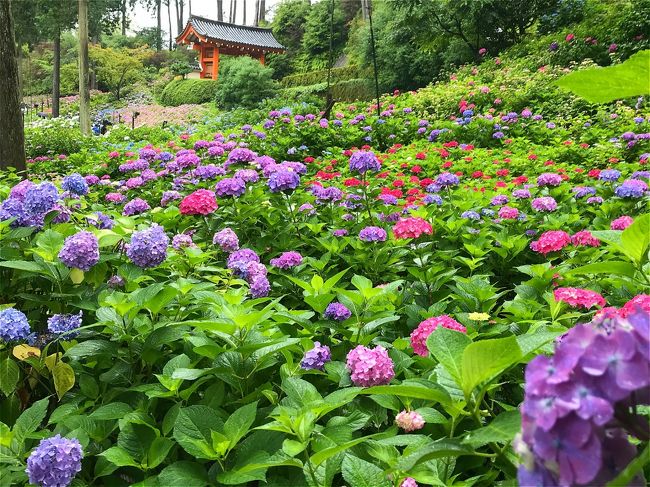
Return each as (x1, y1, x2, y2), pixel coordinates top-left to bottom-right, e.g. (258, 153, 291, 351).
(25, 435, 83, 487)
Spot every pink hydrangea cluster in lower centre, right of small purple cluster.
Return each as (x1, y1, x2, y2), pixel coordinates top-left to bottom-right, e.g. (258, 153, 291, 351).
(346, 345, 395, 387)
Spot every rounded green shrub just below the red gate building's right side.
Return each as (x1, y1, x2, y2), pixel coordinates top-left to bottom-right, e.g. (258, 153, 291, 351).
(216, 57, 278, 108)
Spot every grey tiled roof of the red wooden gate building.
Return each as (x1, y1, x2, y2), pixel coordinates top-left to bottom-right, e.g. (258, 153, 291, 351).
(188, 15, 284, 49)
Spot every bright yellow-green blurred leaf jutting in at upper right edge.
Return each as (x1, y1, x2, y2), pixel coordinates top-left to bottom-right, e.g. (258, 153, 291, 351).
(557, 50, 650, 103)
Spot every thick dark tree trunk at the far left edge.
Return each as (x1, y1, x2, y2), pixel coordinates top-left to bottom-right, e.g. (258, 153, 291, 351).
(0, 0, 25, 171)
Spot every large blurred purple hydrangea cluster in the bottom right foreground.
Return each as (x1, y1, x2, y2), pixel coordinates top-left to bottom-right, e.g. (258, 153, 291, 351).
(515, 309, 650, 485)
